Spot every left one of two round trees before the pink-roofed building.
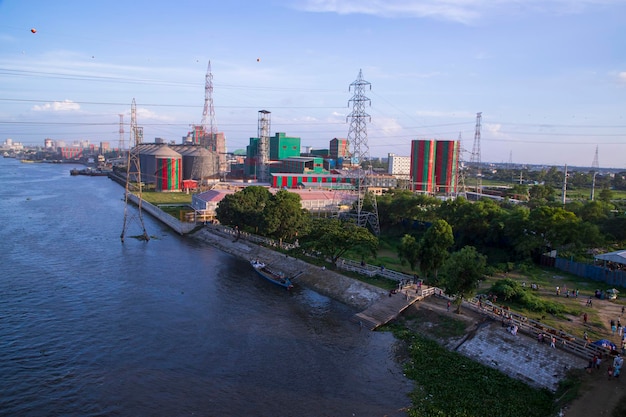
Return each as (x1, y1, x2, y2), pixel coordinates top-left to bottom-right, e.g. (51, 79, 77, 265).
(215, 185, 272, 233)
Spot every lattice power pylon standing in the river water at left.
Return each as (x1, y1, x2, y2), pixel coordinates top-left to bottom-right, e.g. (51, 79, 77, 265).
(120, 98, 150, 243)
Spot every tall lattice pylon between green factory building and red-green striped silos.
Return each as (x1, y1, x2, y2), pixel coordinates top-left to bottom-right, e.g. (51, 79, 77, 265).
(347, 70, 380, 235)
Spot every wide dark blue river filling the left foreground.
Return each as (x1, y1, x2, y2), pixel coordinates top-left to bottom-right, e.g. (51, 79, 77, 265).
(0, 158, 412, 417)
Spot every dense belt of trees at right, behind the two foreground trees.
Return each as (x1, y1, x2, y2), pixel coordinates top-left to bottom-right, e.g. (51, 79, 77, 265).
(378, 186, 626, 262)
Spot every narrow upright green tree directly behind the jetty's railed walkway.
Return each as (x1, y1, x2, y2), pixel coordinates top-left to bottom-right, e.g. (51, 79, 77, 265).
(418, 220, 454, 284)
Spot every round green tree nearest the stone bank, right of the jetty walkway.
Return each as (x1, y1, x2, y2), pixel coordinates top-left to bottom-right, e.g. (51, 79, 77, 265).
(441, 246, 487, 314)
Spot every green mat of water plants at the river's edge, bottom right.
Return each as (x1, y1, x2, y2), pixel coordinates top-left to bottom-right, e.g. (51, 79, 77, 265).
(392, 326, 556, 417)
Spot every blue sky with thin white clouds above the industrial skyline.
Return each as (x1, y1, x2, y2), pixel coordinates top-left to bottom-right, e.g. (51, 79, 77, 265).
(0, 0, 626, 168)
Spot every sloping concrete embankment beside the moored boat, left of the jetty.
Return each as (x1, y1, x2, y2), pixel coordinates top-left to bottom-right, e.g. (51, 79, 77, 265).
(190, 227, 386, 309)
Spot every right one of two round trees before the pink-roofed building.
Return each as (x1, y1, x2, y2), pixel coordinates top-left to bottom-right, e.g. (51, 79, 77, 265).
(263, 190, 311, 241)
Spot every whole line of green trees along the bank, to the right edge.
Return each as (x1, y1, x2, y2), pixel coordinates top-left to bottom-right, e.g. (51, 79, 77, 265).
(217, 186, 626, 310)
